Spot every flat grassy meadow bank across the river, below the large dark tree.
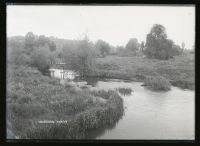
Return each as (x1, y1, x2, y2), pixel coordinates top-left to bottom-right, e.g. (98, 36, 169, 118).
(91, 53, 195, 90)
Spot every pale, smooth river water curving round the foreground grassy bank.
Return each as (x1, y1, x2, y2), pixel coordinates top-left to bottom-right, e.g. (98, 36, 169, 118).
(49, 69, 195, 140)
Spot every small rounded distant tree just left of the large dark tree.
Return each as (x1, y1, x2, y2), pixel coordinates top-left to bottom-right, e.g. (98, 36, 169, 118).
(126, 38, 140, 54)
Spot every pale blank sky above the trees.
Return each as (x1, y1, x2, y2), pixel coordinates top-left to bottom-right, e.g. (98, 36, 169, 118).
(7, 5, 195, 49)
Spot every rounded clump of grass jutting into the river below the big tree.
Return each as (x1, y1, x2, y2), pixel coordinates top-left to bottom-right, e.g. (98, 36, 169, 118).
(143, 76, 171, 91)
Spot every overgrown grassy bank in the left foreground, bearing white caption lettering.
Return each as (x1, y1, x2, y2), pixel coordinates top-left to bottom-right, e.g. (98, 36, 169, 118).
(7, 65, 123, 139)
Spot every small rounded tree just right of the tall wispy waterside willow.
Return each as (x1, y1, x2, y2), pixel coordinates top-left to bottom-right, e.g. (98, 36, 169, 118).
(95, 40, 111, 57)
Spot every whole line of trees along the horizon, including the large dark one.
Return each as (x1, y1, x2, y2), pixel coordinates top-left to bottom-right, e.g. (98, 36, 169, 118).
(7, 24, 188, 76)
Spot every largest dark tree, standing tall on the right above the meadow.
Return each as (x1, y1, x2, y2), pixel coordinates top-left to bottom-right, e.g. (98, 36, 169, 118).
(144, 24, 178, 60)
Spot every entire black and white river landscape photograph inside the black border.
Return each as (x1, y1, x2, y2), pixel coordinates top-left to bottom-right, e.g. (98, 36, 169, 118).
(6, 4, 195, 140)
